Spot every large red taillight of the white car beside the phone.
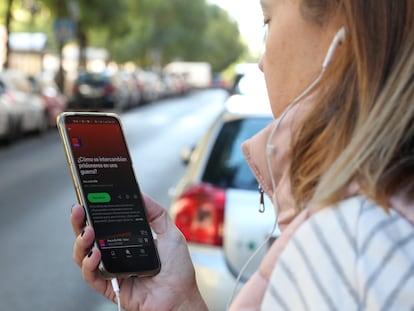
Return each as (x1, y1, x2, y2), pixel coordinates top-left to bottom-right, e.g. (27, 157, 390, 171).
(172, 184, 226, 246)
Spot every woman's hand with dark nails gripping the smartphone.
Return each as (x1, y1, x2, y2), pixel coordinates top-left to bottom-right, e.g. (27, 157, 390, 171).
(71, 195, 207, 311)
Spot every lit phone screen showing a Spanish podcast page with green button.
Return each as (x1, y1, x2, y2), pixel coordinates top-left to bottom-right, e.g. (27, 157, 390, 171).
(66, 117, 153, 261)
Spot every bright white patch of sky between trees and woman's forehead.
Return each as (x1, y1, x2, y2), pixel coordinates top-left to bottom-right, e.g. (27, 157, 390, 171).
(209, 0, 263, 52)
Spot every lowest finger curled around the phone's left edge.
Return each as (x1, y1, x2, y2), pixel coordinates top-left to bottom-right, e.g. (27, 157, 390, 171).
(82, 247, 108, 295)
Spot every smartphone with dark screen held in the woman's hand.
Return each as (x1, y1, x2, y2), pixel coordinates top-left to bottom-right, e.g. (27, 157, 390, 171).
(57, 112, 161, 279)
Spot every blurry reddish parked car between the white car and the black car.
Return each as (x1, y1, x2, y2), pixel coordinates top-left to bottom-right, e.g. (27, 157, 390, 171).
(29, 74, 68, 127)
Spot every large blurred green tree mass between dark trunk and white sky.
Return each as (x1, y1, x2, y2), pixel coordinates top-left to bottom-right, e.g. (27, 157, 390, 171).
(105, 0, 246, 71)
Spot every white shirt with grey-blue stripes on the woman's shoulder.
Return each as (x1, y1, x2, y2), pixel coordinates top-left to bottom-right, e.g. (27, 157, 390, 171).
(261, 196, 414, 311)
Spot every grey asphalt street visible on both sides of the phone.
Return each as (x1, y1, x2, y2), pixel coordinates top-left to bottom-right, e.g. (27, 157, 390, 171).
(0, 90, 225, 311)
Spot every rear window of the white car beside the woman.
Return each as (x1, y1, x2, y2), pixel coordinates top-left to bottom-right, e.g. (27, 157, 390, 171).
(202, 117, 271, 190)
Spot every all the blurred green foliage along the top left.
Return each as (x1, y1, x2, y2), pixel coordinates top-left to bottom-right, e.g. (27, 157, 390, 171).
(0, 0, 246, 72)
